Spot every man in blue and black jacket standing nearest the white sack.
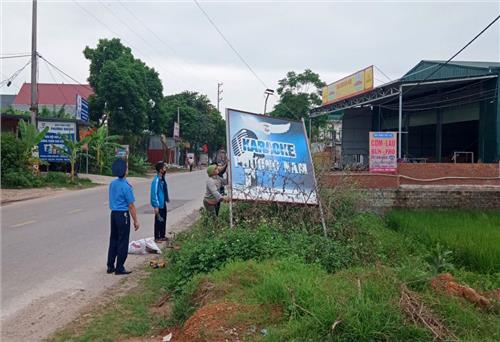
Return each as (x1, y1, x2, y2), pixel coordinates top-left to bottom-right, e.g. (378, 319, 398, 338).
(151, 161, 170, 242)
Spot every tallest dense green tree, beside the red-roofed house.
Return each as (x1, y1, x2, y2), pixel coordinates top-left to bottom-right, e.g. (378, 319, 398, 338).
(83, 38, 165, 146)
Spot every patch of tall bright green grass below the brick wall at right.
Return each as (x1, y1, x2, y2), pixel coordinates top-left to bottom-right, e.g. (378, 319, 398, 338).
(387, 210, 500, 273)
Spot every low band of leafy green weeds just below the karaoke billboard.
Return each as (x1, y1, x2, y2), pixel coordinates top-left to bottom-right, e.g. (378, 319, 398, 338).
(166, 225, 353, 291)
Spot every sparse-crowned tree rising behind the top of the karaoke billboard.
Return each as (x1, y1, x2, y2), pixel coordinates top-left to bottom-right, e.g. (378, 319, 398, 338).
(271, 69, 326, 137)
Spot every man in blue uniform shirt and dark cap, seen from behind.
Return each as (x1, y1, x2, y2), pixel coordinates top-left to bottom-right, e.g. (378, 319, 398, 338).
(107, 159, 139, 275)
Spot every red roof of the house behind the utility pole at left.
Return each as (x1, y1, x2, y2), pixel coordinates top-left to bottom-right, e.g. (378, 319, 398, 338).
(13, 83, 94, 105)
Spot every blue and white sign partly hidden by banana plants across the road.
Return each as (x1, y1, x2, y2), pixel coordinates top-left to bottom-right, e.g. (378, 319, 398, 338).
(38, 120, 76, 162)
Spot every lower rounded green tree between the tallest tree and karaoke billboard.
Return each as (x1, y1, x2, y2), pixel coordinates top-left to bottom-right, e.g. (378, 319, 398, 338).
(161, 91, 226, 152)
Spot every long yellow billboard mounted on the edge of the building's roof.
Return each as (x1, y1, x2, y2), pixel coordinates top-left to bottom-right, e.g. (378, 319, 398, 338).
(323, 66, 373, 105)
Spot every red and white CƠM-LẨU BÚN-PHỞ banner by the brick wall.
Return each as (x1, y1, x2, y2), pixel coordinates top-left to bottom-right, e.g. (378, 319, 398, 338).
(370, 132, 398, 172)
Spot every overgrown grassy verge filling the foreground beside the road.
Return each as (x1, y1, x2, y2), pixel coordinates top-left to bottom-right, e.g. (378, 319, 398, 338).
(49, 208, 500, 342)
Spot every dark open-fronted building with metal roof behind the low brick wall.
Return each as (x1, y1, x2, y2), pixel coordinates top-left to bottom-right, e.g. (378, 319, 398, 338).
(310, 60, 500, 165)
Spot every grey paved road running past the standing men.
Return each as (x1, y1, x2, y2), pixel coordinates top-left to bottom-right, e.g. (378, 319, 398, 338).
(1, 171, 206, 341)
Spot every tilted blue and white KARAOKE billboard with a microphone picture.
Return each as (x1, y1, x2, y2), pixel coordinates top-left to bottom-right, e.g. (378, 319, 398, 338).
(226, 109, 318, 204)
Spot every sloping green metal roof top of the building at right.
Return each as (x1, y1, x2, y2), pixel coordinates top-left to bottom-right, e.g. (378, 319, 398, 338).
(401, 60, 500, 82)
